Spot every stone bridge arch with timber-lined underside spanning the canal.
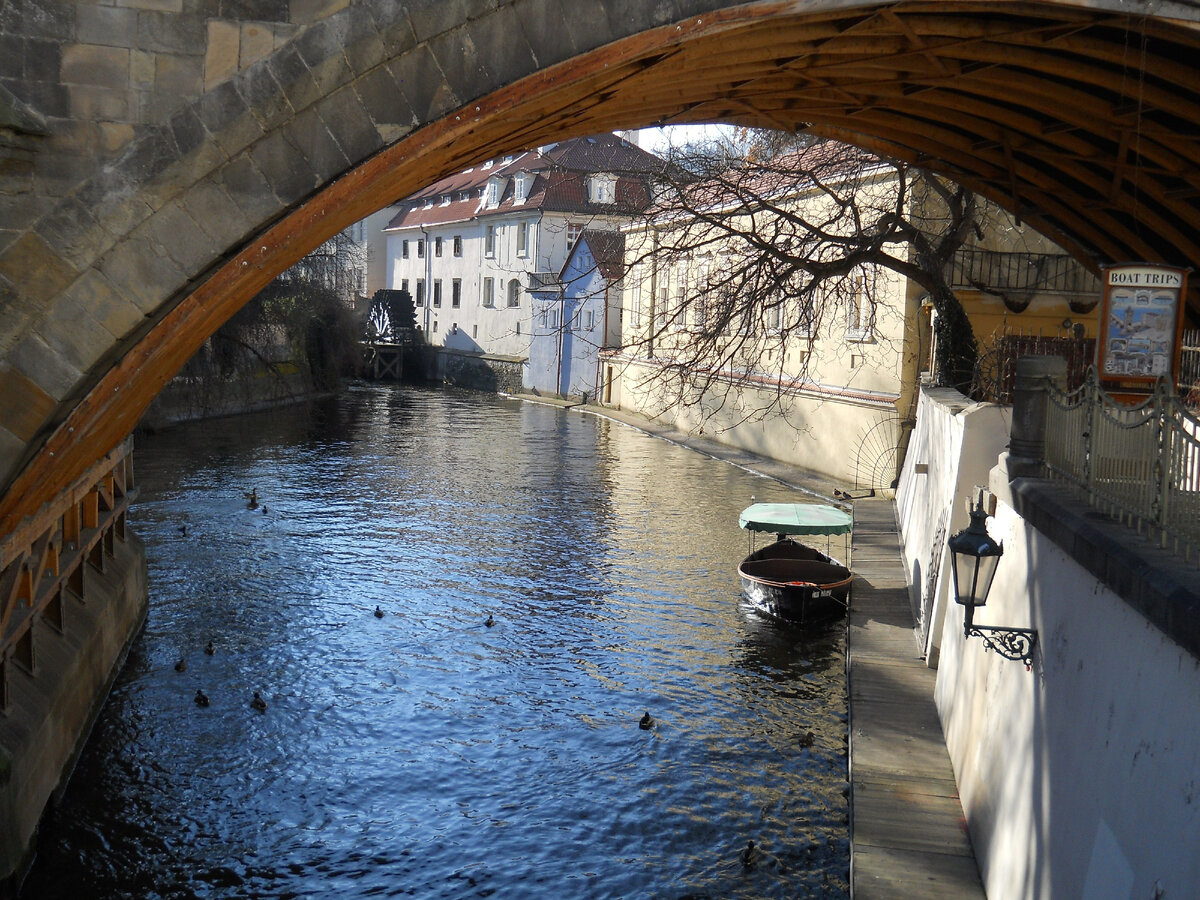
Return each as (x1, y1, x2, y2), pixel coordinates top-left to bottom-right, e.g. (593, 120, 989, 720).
(0, 0, 1200, 535)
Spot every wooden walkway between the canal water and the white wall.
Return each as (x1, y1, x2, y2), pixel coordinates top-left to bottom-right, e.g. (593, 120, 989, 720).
(846, 498, 984, 900)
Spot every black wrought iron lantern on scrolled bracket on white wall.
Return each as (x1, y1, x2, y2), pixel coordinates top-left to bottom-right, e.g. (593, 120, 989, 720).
(947, 491, 1038, 668)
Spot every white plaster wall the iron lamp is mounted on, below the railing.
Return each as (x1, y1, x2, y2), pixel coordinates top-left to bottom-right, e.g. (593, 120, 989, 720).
(936, 482, 1200, 900)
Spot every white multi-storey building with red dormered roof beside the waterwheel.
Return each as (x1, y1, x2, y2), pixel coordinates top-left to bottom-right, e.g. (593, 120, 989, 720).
(385, 134, 661, 359)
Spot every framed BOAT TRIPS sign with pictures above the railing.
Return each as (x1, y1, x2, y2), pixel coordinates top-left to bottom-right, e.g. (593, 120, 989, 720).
(1096, 264, 1188, 389)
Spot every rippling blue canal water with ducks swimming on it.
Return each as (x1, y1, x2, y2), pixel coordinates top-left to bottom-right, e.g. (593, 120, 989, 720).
(23, 385, 848, 900)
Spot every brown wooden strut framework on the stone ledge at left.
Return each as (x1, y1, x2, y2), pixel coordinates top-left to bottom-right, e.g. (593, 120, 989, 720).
(0, 438, 136, 713)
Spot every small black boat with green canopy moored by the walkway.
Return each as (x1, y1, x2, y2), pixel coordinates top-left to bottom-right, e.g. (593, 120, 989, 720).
(738, 503, 854, 625)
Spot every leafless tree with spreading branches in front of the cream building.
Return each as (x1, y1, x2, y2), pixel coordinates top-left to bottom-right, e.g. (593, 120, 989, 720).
(625, 133, 979, 420)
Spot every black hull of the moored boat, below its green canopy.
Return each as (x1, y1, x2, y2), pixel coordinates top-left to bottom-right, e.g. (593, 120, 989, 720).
(738, 539, 854, 625)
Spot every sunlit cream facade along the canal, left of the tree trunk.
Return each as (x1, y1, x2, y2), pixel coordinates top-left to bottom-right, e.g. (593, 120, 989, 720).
(606, 152, 925, 490)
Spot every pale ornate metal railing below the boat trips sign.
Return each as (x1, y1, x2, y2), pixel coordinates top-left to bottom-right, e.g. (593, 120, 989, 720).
(1045, 371, 1200, 563)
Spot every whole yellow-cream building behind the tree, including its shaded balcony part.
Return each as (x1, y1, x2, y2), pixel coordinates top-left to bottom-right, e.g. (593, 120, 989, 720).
(601, 145, 1098, 491)
